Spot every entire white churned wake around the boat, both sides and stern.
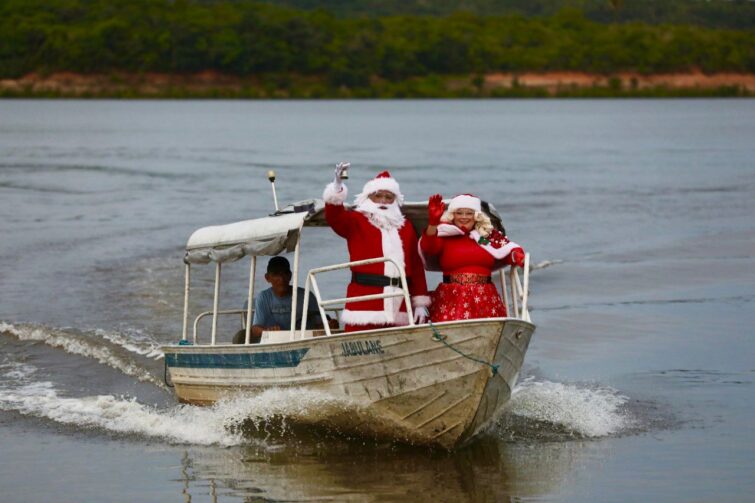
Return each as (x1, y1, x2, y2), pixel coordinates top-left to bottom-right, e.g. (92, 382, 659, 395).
(0, 322, 636, 446)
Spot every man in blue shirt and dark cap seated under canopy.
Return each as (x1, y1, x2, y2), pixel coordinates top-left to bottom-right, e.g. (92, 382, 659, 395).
(233, 256, 337, 344)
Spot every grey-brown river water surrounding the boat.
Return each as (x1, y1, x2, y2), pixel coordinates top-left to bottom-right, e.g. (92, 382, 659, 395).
(0, 100, 755, 502)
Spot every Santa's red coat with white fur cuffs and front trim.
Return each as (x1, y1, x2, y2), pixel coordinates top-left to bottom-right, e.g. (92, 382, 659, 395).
(324, 185, 430, 329)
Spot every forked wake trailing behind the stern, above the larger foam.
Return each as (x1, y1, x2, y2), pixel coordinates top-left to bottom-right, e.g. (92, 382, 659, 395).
(0, 322, 165, 388)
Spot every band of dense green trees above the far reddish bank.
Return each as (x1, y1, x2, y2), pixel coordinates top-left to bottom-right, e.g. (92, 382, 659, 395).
(0, 0, 755, 87)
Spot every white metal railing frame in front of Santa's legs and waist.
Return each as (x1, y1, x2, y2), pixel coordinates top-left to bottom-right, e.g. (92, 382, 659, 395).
(299, 257, 414, 338)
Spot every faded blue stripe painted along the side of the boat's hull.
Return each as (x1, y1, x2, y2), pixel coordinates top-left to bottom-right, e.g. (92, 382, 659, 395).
(165, 348, 309, 369)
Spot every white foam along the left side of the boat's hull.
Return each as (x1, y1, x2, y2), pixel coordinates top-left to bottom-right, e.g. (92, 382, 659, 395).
(0, 382, 358, 446)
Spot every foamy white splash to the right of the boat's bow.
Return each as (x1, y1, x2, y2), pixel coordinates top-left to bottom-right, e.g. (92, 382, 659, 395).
(495, 378, 636, 441)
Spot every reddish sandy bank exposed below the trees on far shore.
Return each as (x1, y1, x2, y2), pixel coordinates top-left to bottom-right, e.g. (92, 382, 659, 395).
(0, 71, 755, 98)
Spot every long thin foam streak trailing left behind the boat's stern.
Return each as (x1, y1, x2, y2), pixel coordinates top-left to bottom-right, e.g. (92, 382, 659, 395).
(0, 322, 164, 387)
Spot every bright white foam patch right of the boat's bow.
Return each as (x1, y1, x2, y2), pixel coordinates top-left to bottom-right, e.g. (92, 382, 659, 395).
(506, 379, 631, 437)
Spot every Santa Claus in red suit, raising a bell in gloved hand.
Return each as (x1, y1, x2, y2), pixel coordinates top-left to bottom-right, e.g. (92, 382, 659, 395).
(323, 163, 430, 332)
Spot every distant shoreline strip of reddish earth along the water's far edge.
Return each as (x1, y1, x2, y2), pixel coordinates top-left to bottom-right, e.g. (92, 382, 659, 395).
(0, 71, 755, 99)
